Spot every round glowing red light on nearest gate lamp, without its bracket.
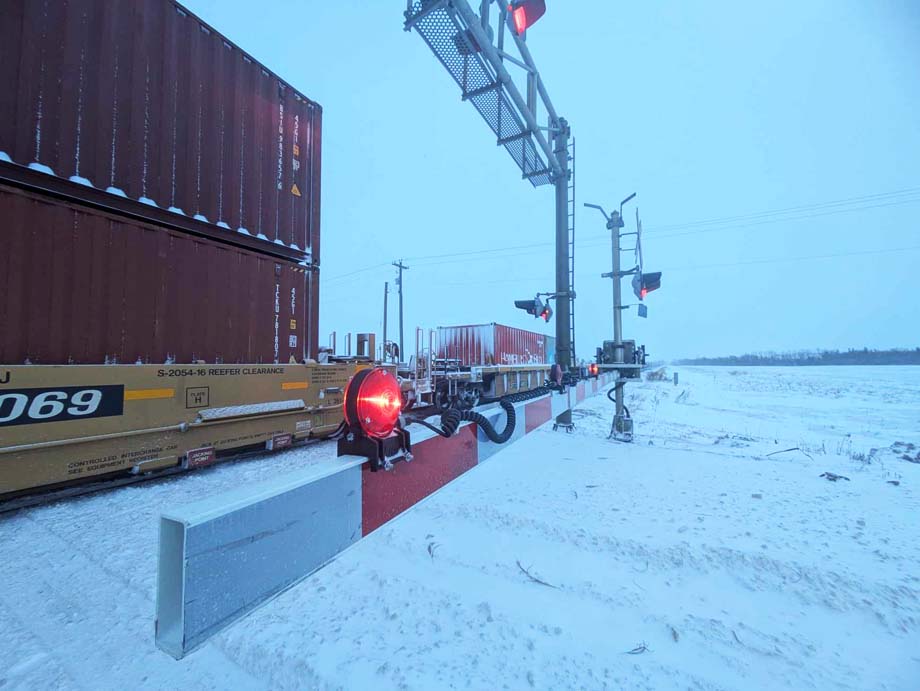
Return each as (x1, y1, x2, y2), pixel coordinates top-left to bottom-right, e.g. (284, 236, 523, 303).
(343, 367, 402, 439)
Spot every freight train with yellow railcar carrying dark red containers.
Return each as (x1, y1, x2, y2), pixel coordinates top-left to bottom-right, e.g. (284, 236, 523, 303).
(0, 0, 568, 510)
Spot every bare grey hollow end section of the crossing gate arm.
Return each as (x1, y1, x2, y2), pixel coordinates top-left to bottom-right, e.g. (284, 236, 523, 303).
(156, 456, 365, 659)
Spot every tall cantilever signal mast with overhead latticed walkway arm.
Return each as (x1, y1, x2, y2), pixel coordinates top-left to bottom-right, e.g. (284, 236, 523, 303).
(404, 0, 575, 428)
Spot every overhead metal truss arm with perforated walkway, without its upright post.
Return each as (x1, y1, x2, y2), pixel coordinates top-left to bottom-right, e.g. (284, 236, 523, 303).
(404, 0, 567, 187)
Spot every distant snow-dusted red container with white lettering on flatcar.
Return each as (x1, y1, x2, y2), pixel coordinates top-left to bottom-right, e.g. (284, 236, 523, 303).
(438, 323, 547, 367)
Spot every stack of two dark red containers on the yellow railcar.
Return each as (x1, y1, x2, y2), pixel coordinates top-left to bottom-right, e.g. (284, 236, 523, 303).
(0, 0, 322, 364)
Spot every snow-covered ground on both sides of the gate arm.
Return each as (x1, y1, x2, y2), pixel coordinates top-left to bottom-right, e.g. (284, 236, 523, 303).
(0, 367, 920, 691)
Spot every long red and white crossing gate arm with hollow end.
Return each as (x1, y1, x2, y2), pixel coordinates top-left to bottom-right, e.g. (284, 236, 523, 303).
(156, 374, 614, 659)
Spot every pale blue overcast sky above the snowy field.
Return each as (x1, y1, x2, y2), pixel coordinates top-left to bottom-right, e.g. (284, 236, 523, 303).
(185, 0, 920, 358)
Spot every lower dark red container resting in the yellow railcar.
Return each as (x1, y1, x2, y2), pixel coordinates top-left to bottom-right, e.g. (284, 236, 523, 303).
(0, 185, 317, 364)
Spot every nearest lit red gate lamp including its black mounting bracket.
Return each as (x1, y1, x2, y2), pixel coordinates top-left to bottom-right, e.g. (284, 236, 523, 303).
(338, 367, 412, 471)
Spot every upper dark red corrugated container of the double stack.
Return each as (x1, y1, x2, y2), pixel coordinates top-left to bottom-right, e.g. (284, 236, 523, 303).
(0, 0, 322, 263)
